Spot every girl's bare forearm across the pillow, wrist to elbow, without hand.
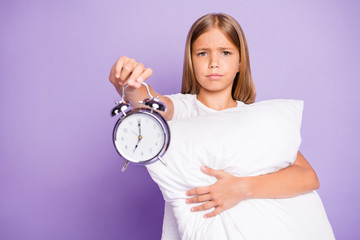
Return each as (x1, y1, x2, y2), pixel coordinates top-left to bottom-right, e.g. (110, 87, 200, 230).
(245, 152, 319, 198)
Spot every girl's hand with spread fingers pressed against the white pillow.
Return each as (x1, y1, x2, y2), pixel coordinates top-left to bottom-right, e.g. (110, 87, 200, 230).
(186, 167, 251, 218)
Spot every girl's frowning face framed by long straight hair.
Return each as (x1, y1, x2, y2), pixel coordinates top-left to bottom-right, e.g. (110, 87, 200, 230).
(191, 28, 240, 95)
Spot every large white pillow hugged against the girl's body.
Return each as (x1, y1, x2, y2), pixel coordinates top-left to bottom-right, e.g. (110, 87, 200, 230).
(147, 100, 331, 239)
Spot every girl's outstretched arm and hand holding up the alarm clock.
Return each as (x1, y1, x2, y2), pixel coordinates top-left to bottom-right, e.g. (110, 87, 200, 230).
(109, 56, 174, 121)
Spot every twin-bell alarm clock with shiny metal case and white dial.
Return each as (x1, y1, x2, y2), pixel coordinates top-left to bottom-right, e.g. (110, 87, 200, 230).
(111, 82, 170, 172)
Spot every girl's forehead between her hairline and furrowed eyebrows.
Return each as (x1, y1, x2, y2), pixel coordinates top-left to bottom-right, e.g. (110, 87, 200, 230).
(193, 28, 236, 49)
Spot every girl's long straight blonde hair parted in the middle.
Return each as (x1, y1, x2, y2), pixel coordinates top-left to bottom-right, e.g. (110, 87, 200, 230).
(181, 13, 256, 104)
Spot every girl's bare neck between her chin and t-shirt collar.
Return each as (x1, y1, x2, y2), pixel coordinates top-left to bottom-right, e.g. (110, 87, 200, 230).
(196, 91, 237, 111)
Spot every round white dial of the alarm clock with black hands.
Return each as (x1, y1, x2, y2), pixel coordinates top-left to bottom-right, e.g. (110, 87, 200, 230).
(114, 112, 165, 162)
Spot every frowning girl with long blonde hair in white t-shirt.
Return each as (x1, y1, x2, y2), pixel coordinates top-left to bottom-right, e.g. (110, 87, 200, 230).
(109, 14, 333, 239)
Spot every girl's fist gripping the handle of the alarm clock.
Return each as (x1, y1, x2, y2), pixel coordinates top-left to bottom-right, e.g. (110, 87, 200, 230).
(109, 56, 152, 88)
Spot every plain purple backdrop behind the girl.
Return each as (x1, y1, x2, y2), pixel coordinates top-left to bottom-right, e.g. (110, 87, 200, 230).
(0, 0, 360, 240)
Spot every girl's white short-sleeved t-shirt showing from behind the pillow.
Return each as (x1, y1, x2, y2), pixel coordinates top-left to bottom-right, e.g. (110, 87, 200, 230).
(161, 93, 245, 240)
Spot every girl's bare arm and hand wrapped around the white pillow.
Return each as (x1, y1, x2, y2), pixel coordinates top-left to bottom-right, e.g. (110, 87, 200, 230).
(186, 152, 319, 217)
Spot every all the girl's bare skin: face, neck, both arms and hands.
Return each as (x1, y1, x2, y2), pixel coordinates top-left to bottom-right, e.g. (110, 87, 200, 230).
(109, 28, 319, 217)
